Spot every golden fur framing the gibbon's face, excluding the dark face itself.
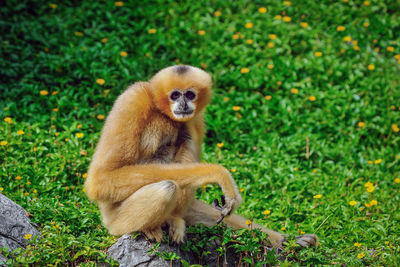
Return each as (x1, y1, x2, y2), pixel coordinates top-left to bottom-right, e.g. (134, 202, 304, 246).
(149, 65, 212, 120)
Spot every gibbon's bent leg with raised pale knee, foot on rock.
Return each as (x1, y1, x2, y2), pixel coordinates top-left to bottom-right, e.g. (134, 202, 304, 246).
(99, 181, 180, 242)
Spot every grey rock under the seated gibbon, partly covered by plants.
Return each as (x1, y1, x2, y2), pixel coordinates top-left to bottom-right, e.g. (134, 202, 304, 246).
(107, 235, 239, 267)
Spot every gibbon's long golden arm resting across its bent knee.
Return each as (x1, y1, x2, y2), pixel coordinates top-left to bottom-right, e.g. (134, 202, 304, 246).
(86, 163, 239, 205)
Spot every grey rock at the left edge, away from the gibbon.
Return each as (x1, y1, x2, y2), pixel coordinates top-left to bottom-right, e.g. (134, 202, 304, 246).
(0, 194, 40, 265)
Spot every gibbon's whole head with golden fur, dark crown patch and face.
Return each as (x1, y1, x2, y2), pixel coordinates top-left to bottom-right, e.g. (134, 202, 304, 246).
(150, 65, 212, 122)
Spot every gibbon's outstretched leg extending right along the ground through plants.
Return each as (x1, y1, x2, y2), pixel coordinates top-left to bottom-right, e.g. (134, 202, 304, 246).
(184, 199, 318, 247)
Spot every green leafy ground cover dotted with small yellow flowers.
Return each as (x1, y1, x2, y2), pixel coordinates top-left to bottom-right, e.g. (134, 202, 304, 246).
(0, 0, 400, 266)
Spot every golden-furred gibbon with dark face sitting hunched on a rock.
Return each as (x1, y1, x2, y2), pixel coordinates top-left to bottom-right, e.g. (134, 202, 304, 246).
(85, 65, 317, 249)
